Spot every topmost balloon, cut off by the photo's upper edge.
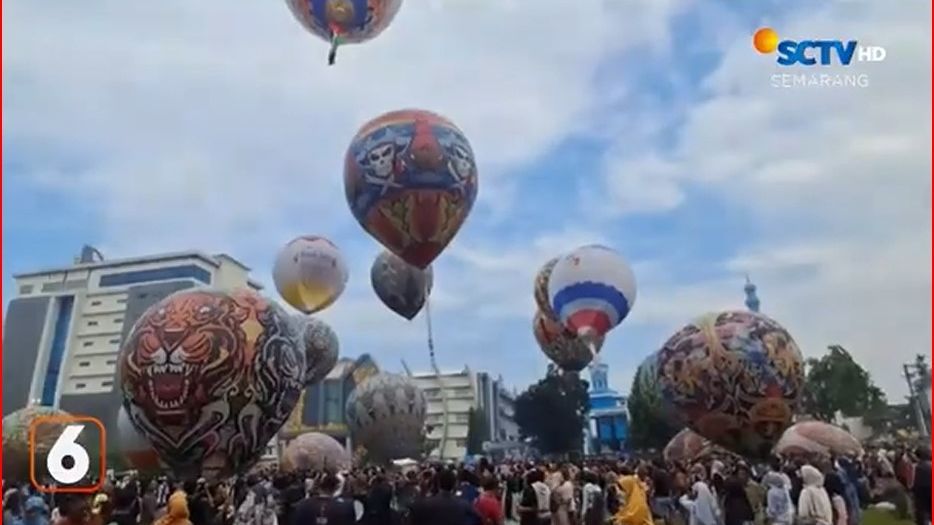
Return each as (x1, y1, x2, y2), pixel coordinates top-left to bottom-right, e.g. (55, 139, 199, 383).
(286, 0, 402, 65)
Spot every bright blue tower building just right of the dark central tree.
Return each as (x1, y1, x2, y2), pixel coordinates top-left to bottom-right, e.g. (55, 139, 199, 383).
(587, 361, 629, 454)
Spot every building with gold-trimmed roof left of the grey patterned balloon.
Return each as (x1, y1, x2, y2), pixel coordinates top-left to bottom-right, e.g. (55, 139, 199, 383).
(279, 354, 379, 450)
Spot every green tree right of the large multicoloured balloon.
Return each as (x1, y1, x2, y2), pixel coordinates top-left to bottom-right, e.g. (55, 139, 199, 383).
(804, 345, 887, 421)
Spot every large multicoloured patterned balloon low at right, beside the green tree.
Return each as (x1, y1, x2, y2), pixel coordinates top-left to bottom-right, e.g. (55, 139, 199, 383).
(658, 311, 804, 458)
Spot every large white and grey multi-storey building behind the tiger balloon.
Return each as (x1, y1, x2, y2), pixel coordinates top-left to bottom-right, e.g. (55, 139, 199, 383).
(2, 247, 262, 438)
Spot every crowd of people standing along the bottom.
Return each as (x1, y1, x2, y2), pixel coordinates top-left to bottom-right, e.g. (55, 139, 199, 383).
(3, 448, 931, 525)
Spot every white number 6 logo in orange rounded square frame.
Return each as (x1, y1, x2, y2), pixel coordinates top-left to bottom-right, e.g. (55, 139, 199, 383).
(29, 416, 107, 494)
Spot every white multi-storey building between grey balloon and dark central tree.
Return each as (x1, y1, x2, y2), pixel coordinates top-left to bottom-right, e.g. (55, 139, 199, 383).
(412, 367, 519, 460)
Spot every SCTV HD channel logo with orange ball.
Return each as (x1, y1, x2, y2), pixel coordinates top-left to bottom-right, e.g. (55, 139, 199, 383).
(752, 27, 885, 67)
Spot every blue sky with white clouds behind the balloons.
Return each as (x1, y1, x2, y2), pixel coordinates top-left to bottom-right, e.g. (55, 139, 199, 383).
(3, 0, 931, 399)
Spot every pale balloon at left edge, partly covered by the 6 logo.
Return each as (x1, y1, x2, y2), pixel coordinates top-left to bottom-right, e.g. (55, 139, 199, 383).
(3, 405, 69, 480)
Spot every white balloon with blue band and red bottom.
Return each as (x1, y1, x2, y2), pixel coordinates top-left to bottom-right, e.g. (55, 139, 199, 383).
(548, 245, 636, 339)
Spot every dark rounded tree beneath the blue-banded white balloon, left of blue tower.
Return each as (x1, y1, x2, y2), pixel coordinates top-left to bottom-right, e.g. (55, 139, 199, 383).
(515, 368, 590, 454)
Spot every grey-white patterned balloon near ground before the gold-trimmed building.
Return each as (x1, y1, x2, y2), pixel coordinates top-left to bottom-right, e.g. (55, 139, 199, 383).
(347, 373, 426, 461)
